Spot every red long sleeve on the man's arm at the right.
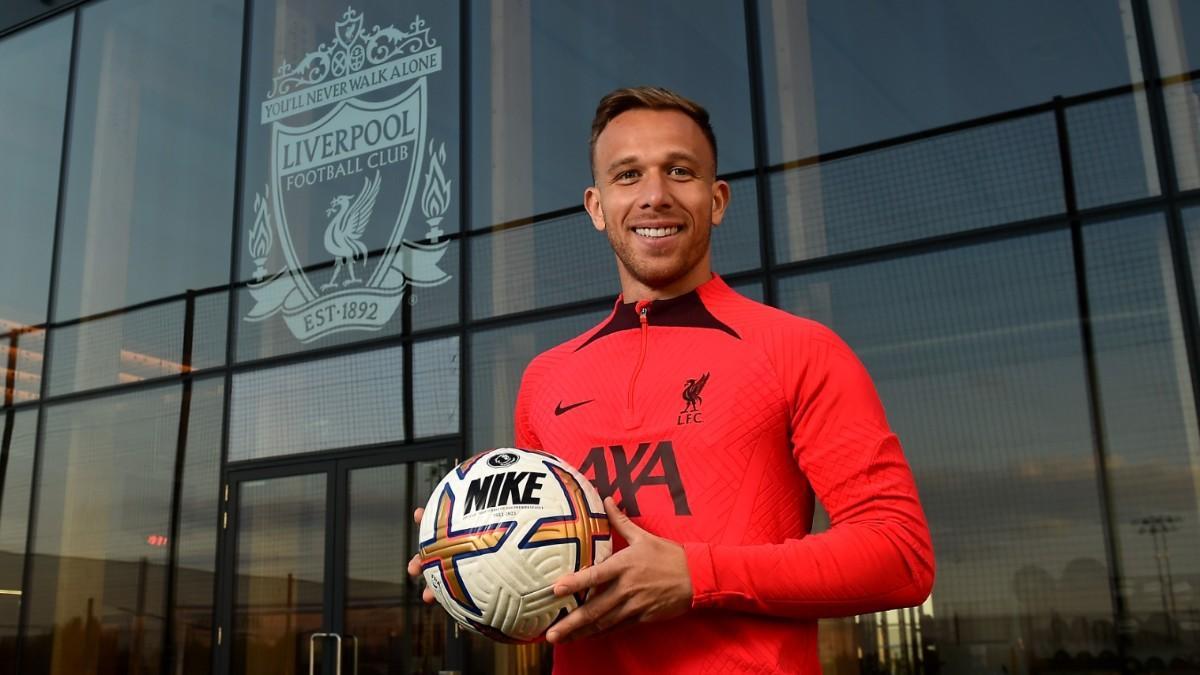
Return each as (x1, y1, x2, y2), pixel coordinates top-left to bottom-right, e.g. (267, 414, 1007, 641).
(685, 324, 934, 619)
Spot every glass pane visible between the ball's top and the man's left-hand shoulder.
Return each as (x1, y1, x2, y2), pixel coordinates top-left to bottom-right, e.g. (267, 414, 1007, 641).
(468, 310, 610, 452)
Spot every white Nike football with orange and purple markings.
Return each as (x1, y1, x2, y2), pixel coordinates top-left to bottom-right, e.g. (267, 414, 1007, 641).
(420, 448, 612, 643)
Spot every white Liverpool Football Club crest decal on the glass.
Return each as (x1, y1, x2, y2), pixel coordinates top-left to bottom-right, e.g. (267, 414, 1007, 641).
(245, 8, 452, 342)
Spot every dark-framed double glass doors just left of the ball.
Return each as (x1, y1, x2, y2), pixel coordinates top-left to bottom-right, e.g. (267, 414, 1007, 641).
(218, 450, 461, 675)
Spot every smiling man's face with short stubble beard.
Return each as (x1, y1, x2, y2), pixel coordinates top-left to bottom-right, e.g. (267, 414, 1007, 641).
(583, 109, 730, 300)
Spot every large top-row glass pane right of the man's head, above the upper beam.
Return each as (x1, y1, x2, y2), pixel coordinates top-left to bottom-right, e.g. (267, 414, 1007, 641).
(746, 0, 1141, 163)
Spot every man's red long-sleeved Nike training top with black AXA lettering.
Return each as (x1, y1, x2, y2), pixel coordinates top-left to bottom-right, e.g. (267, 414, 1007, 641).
(516, 277, 934, 675)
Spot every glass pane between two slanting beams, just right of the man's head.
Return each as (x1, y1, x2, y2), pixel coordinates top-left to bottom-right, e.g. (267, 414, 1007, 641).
(769, 114, 1066, 262)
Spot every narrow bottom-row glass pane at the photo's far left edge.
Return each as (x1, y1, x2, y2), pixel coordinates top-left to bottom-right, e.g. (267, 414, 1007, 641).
(0, 403, 37, 663)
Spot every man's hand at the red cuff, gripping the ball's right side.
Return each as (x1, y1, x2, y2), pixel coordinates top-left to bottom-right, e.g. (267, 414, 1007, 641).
(546, 497, 691, 643)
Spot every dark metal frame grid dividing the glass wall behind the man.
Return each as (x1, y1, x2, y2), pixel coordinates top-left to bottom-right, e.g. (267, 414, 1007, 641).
(0, 0, 1200, 670)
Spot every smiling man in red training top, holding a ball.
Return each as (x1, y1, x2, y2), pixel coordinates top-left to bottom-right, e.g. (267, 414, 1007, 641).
(410, 88, 934, 674)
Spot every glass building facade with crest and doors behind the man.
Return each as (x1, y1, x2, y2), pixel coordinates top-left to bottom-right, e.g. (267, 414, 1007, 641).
(0, 0, 1200, 675)
